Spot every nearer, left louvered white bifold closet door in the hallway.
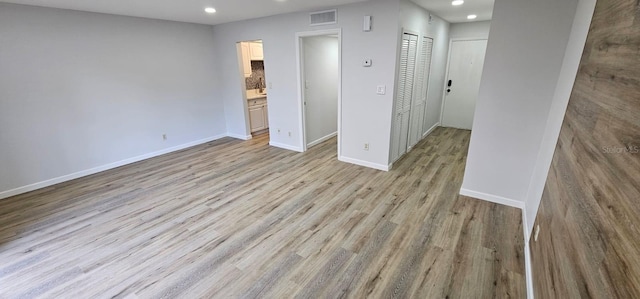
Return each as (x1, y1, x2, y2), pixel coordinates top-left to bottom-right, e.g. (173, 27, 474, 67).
(392, 33, 418, 161)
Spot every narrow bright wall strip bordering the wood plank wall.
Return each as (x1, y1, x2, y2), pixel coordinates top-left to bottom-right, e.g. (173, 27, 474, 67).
(524, 0, 596, 241)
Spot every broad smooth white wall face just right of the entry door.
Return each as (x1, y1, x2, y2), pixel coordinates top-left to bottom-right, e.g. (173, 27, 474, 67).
(461, 0, 577, 207)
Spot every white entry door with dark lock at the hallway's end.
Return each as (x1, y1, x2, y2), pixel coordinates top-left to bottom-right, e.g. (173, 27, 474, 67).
(442, 40, 487, 130)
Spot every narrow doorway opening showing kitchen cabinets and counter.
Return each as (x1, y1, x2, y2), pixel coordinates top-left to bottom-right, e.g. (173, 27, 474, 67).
(237, 40, 269, 142)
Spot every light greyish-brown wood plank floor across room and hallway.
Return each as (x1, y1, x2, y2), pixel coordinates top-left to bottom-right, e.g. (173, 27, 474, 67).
(0, 128, 525, 298)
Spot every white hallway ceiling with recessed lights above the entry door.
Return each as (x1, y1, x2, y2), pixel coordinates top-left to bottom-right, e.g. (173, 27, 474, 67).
(411, 0, 496, 23)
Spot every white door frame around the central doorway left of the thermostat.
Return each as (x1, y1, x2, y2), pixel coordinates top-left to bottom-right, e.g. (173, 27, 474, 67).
(296, 28, 342, 157)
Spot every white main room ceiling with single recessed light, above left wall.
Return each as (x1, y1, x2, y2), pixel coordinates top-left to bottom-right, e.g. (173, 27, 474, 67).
(0, 0, 367, 25)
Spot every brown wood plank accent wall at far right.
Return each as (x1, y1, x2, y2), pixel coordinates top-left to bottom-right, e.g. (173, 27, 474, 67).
(530, 0, 640, 298)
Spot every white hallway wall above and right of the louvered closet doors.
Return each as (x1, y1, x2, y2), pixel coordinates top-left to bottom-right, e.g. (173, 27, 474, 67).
(400, 0, 449, 134)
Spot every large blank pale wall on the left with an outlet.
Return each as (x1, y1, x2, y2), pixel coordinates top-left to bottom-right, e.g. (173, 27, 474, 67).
(0, 3, 225, 197)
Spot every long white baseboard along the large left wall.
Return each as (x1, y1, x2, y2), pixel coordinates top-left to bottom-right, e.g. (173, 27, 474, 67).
(0, 134, 227, 199)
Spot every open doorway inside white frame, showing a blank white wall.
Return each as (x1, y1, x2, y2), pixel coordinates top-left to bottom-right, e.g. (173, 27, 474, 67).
(297, 30, 341, 152)
